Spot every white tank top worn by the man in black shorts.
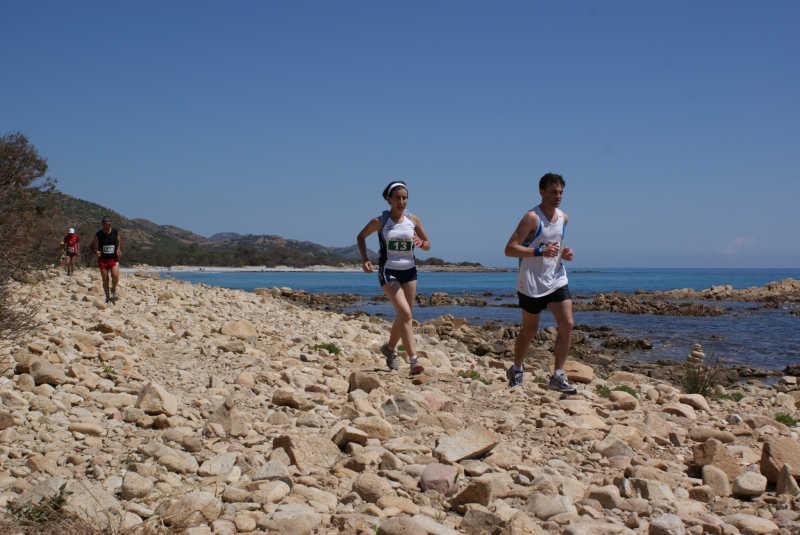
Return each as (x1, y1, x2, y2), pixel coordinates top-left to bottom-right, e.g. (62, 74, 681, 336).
(517, 206, 568, 297)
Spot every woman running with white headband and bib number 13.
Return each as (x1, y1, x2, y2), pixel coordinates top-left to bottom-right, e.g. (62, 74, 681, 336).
(358, 181, 431, 375)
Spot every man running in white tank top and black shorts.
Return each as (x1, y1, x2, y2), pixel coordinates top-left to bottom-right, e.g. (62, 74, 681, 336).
(505, 173, 577, 394)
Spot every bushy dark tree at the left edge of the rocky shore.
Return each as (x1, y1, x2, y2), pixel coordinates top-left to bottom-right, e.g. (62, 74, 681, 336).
(0, 132, 58, 346)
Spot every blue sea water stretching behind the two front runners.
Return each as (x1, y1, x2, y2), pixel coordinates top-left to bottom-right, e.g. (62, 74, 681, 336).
(164, 268, 800, 369)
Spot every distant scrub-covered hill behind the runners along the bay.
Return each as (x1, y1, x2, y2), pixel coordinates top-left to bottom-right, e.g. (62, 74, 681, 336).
(54, 191, 378, 267)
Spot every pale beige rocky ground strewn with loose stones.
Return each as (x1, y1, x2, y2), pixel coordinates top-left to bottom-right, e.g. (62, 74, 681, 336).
(0, 271, 800, 535)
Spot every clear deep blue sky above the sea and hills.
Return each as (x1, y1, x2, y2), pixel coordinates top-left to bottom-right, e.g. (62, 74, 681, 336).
(0, 0, 800, 267)
